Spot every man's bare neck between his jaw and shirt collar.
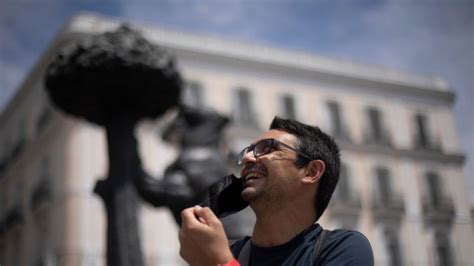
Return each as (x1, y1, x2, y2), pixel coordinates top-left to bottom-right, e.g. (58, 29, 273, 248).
(252, 202, 316, 247)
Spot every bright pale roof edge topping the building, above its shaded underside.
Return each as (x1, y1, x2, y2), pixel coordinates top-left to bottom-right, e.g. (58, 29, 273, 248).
(65, 13, 449, 92)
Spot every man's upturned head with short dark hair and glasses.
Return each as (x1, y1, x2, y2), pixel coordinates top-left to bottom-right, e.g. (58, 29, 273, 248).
(242, 117, 340, 219)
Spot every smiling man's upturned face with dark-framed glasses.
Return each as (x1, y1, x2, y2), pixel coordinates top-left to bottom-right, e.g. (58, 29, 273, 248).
(241, 130, 304, 205)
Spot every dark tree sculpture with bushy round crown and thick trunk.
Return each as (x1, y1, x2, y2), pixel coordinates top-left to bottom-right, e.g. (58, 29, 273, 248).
(45, 25, 182, 266)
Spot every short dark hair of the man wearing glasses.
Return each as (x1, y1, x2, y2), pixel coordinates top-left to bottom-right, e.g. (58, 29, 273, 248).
(270, 116, 341, 220)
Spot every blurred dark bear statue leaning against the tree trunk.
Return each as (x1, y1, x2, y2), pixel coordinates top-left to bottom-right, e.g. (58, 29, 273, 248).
(135, 105, 251, 239)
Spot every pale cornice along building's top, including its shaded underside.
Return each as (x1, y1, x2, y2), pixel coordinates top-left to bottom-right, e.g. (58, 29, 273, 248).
(64, 13, 455, 104)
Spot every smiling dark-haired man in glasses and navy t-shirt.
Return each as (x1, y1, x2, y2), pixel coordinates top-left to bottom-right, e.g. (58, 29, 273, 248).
(180, 117, 373, 266)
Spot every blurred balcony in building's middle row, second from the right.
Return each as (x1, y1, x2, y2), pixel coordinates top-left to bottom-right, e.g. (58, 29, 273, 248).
(372, 194, 405, 222)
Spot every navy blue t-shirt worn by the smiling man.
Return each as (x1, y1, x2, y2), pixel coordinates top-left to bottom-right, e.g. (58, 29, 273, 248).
(230, 224, 374, 266)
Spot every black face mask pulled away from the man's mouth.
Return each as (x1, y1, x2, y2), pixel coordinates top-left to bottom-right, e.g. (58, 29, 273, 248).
(201, 174, 249, 218)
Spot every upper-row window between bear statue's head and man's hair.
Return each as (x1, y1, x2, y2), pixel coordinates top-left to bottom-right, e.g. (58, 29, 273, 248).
(233, 88, 257, 127)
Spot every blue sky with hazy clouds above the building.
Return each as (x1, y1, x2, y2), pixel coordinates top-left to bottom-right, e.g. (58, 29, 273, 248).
(0, 0, 474, 203)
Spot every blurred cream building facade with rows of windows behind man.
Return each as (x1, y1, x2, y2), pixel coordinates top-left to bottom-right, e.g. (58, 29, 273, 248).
(0, 14, 474, 265)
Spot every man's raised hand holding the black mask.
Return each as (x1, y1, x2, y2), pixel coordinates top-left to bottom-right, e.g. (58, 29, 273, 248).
(179, 206, 233, 266)
